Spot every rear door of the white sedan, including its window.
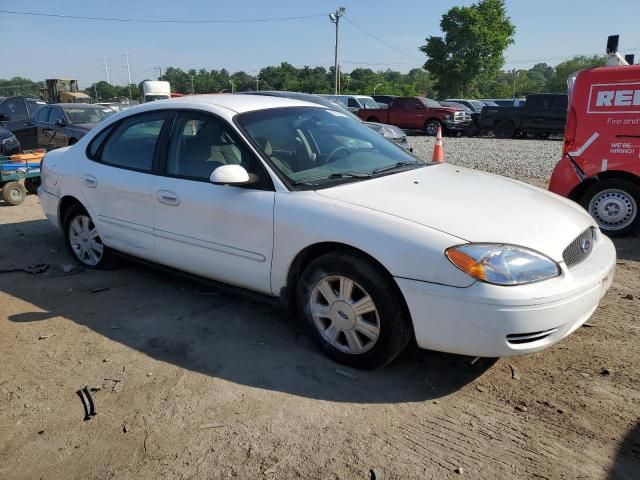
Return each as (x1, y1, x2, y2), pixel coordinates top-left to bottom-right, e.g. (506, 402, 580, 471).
(79, 111, 167, 261)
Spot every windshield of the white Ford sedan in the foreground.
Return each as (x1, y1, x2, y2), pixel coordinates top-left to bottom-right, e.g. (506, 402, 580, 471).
(236, 107, 427, 189)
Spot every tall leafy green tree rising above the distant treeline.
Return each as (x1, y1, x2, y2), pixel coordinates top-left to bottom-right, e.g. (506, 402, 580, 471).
(420, 0, 515, 96)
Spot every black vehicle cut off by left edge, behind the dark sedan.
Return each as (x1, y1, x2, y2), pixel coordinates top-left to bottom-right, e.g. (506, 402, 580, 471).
(0, 96, 46, 149)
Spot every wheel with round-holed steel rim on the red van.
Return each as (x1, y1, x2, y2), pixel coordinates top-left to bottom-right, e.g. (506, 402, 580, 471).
(580, 178, 640, 237)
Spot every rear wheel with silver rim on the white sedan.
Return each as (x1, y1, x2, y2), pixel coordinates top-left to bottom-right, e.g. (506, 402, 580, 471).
(62, 204, 117, 270)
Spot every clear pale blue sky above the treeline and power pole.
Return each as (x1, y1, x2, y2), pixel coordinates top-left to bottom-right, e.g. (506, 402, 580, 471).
(0, 0, 640, 88)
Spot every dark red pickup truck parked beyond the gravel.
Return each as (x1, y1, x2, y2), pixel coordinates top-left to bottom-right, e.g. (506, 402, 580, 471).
(357, 97, 471, 136)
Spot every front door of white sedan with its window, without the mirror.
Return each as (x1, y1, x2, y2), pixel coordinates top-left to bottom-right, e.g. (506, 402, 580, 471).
(153, 111, 275, 293)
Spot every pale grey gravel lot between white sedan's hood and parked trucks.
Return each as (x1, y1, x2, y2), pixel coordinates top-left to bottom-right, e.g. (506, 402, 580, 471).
(409, 136, 562, 187)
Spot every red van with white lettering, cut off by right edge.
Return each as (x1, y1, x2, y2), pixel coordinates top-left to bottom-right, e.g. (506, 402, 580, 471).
(549, 52, 640, 236)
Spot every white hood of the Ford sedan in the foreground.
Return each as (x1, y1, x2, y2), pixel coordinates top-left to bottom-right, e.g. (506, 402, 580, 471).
(317, 164, 595, 261)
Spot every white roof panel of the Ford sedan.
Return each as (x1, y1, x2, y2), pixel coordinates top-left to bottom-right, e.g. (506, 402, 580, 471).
(162, 93, 326, 113)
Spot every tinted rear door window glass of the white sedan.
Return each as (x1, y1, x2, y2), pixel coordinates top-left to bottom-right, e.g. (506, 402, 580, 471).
(99, 112, 166, 172)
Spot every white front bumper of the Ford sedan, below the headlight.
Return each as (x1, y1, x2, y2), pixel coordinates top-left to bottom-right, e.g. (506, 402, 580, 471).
(396, 233, 616, 357)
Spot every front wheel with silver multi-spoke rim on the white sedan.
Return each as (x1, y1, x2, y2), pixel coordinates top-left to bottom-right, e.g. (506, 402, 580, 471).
(296, 253, 413, 369)
